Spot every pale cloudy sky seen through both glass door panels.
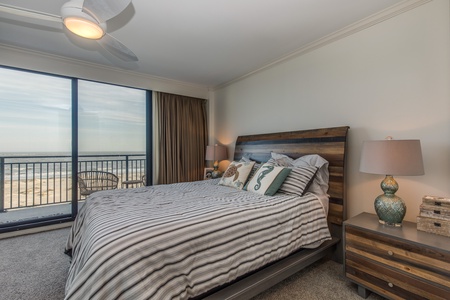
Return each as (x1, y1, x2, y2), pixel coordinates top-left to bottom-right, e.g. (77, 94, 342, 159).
(0, 68, 146, 153)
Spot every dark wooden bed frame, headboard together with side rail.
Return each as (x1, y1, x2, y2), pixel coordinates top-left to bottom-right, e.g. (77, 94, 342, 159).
(202, 126, 349, 300)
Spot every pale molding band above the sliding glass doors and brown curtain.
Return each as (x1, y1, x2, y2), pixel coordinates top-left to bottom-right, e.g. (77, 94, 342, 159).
(0, 43, 210, 98)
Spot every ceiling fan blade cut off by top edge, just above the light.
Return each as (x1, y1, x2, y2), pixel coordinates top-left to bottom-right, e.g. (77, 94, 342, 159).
(82, 0, 131, 23)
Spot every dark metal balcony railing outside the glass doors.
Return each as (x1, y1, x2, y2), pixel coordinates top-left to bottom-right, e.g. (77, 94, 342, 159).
(0, 154, 146, 211)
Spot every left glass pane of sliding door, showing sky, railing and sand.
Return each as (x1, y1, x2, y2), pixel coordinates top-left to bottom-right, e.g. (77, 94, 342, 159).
(0, 68, 72, 223)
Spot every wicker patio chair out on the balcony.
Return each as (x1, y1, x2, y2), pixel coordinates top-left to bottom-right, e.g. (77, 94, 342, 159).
(78, 171, 119, 196)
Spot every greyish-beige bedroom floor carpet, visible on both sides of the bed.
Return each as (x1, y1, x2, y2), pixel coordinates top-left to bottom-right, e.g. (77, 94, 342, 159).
(0, 228, 383, 300)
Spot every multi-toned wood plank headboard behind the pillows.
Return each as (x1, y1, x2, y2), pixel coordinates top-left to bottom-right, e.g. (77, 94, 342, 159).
(234, 126, 349, 234)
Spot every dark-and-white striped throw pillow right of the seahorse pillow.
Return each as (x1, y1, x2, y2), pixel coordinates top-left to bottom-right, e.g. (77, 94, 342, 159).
(278, 166, 318, 196)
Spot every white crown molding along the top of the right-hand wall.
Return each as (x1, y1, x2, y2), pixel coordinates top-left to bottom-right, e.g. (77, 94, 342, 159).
(212, 0, 433, 91)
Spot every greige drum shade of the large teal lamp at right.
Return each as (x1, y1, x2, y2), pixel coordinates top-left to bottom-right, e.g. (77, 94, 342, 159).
(359, 140, 424, 176)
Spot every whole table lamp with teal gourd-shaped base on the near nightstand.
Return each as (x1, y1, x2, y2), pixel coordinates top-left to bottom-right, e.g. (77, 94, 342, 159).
(359, 137, 424, 227)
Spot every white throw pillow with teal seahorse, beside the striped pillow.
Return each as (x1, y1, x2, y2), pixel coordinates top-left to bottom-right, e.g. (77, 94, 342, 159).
(246, 163, 291, 196)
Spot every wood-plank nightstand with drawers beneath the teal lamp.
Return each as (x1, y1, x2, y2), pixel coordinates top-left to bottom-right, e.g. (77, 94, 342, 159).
(343, 213, 450, 299)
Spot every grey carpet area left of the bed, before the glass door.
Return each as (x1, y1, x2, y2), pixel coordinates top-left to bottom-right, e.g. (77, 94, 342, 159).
(0, 228, 70, 300)
